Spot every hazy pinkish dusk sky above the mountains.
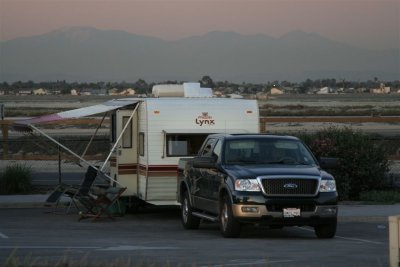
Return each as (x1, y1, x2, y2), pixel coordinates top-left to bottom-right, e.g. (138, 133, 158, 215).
(0, 0, 400, 49)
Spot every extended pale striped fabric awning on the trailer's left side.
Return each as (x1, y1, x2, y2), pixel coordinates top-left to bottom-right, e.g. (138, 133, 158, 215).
(13, 99, 140, 131)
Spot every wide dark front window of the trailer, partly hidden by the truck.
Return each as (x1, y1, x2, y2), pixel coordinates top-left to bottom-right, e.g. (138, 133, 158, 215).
(166, 134, 208, 157)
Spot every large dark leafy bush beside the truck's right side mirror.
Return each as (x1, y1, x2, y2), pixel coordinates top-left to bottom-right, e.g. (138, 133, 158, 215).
(300, 126, 389, 200)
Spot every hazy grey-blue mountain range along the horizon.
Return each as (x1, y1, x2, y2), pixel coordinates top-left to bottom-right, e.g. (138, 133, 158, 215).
(0, 27, 400, 82)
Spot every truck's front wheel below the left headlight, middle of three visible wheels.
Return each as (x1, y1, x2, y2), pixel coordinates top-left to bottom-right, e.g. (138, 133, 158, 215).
(219, 195, 242, 237)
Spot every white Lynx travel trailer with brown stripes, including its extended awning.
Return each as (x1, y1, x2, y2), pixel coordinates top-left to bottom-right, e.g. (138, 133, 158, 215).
(14, 83, 259, 205)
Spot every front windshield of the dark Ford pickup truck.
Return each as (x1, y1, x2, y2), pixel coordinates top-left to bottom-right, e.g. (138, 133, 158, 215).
(223, 138, 316, 165)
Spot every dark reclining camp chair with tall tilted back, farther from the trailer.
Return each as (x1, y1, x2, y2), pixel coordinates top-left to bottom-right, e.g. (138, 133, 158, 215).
(45, 166, 97, 213)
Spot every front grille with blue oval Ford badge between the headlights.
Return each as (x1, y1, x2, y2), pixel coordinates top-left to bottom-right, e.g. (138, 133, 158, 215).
(261, 178, 319, 196)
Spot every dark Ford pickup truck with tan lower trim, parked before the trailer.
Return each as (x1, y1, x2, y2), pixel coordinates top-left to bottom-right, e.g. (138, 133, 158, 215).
(178, 134, 338, 238)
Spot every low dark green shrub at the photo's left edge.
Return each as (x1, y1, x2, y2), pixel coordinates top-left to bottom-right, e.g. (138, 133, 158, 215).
(0, 164, 32, 195)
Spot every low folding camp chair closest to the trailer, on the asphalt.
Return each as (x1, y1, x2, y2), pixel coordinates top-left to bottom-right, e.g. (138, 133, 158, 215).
(78, 187, 126, 221)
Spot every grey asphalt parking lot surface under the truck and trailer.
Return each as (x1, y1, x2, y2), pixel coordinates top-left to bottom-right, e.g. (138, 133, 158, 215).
(0, 205, 400, 267)
